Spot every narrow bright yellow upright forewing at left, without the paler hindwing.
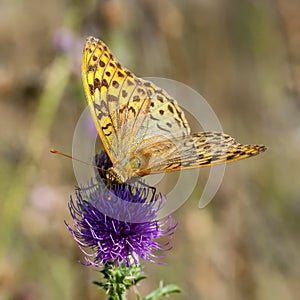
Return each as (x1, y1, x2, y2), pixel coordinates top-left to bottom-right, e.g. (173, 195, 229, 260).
(82, 37, 150, 163)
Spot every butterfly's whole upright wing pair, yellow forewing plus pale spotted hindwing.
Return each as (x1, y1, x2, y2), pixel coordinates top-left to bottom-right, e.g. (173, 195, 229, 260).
(82, 37, 190, 163)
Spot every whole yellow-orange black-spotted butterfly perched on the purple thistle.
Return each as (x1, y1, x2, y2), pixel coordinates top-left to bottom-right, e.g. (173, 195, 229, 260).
(82, 37, 266, 183)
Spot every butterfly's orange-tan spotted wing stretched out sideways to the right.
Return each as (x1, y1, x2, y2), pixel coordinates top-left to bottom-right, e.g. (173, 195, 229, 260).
(132, 132, 266, 176)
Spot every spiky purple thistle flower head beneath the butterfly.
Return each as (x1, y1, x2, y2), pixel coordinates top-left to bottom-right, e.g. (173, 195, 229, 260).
(67, 152, 177, 267)
